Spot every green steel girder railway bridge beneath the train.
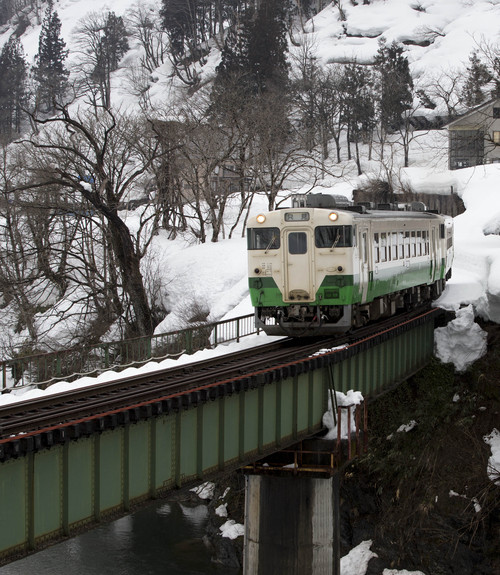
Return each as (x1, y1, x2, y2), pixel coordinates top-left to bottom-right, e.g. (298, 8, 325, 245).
(0, 310, 446, 573)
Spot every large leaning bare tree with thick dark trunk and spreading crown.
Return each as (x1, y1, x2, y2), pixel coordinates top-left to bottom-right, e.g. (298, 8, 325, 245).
(14, 103, 164, 335)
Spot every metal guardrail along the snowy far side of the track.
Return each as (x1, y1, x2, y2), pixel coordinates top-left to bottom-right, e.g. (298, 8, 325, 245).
(0, 314, 259, 392)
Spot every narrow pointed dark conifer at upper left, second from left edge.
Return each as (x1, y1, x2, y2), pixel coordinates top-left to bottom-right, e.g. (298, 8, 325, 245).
(33, 2, 69, 112)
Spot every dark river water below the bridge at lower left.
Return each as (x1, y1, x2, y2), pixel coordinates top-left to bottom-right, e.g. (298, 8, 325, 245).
(0, 501, 238, 575)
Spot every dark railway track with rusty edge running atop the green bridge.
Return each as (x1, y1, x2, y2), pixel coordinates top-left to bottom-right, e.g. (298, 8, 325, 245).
(0, 310, 444, 459)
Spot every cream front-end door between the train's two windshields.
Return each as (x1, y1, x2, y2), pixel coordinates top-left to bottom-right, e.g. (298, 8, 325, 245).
(283, 230, 316, 301)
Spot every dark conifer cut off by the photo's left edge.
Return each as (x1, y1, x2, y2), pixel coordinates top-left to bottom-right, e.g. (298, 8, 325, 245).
(0, 36, 26, 141)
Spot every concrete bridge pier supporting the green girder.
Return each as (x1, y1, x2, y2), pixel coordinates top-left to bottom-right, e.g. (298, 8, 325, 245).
(243, 474, 340, 575)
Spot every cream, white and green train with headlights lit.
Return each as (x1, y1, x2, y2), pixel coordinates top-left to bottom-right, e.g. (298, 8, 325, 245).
(247, 194, 453, 337)
